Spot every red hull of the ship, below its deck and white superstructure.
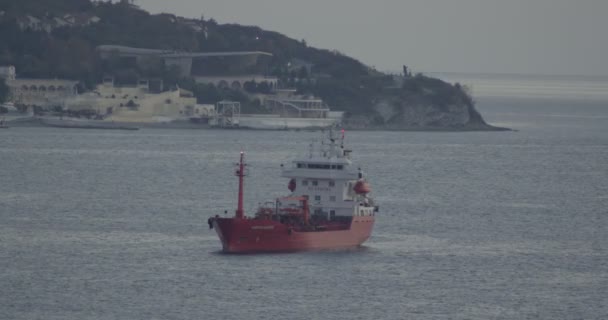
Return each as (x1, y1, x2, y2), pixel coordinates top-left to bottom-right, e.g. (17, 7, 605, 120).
(213, 216, 374, 253)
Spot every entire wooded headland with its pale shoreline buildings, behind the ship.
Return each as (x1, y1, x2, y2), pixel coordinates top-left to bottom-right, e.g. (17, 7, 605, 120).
(0, 0, 508, 131)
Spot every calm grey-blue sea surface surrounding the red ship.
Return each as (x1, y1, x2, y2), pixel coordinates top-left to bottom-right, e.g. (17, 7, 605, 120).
(0, 74, 608, 320)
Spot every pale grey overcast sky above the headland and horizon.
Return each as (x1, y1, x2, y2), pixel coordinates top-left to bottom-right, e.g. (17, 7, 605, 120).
(135, 0, 608, 76)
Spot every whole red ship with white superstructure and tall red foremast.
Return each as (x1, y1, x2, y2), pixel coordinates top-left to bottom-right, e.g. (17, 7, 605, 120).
(208, 130, 378, 253)
